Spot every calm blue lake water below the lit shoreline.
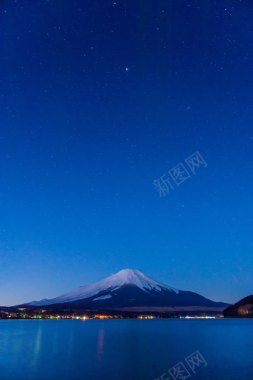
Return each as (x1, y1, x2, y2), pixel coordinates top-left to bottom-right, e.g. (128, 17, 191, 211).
(0, 319, 253, 380)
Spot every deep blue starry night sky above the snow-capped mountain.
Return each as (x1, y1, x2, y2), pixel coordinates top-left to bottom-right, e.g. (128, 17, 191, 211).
(0, 0, 253, 305)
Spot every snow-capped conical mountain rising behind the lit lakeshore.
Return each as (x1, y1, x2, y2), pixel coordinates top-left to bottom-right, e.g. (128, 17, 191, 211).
(27, 269, 227, 310)
